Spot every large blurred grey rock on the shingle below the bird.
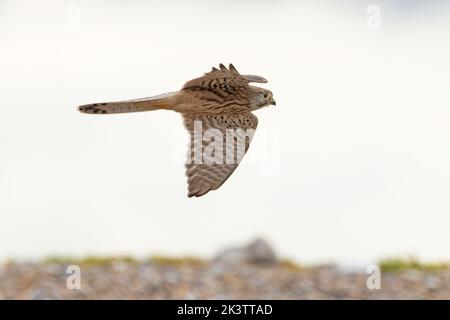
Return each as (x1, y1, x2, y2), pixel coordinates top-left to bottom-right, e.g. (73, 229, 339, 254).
(213, 238, 277, 265)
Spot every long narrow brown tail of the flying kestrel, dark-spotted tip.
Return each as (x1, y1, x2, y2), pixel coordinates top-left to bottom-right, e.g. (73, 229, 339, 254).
(78, 93, 175, 114)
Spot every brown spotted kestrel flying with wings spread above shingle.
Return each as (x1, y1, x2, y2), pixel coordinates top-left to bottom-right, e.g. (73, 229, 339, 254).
(78, 64, 275, 197)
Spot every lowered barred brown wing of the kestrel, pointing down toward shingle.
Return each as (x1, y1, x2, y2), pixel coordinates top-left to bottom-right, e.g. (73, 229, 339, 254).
(183, 113, 258, 197)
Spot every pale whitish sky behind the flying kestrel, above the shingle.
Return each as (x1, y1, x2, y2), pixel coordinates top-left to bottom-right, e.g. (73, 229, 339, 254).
(0, 0, 450, 265)
